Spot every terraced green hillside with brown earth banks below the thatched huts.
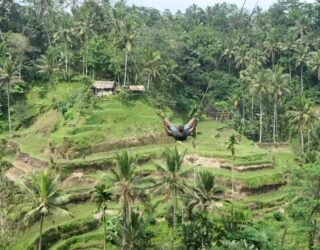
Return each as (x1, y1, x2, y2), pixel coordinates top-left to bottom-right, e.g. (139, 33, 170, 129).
(1, 80, 292, 249)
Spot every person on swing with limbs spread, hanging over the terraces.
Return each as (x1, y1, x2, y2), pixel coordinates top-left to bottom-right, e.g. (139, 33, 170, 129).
(161, 115, 197, 141)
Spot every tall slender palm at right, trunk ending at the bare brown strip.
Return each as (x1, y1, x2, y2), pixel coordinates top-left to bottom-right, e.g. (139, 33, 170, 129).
(268, 65, 290, 143)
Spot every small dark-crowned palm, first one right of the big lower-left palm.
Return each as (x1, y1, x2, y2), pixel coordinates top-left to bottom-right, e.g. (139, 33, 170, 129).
(92, 184, 111, 250)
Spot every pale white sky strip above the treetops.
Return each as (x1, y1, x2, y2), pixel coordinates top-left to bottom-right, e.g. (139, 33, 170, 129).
(123, 0, 315, 13)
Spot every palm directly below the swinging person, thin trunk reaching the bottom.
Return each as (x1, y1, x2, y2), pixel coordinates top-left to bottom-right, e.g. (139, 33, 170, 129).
(154, 147, 192, 249)
